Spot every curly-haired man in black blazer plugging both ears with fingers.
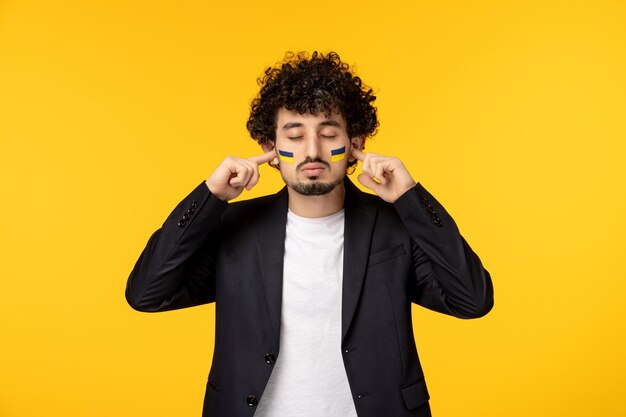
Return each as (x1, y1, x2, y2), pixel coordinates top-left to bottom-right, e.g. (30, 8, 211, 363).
(126, 53, 493, 417)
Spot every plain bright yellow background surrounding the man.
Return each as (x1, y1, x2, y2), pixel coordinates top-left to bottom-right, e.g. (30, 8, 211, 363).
(0, 0, 626, 417)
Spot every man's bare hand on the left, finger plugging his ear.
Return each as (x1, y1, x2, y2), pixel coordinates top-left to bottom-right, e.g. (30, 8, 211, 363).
(206, 149, 276, 201)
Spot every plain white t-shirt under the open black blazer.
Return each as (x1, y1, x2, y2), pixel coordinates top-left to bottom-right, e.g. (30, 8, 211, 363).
(254, 210, 357, 417)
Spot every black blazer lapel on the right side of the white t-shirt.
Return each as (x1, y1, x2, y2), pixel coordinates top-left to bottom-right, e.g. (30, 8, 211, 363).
(341, 177, 377, 341)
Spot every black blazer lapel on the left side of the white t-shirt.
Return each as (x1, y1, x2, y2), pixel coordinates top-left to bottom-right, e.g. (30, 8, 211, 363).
(254, 188, 289, 346)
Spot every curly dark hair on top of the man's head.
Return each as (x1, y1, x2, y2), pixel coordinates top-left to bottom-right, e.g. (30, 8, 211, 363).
(246, 51, 378, 153)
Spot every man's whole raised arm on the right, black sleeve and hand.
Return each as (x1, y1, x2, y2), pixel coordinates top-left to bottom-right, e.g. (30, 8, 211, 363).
(352, 149, 493, 318)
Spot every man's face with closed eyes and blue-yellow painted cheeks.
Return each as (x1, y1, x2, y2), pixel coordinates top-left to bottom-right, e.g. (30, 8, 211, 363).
(264, 108, 362, 195)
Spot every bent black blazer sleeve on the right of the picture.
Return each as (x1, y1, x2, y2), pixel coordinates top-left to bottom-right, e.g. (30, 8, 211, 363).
(394, 183, 493, 319)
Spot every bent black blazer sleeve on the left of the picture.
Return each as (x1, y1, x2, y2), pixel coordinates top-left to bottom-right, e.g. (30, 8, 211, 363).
(126, 181, 228, 312)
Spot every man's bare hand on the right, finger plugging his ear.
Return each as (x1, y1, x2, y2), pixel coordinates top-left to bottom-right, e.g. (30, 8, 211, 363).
(351, 148, 416, 203)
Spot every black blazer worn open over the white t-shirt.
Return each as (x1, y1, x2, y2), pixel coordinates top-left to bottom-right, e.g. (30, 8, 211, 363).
(126, 179, 493, 417)
